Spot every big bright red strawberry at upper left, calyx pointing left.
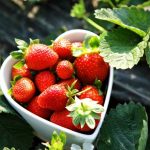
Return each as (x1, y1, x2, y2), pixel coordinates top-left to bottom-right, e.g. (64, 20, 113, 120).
(25, 44, 58, 70)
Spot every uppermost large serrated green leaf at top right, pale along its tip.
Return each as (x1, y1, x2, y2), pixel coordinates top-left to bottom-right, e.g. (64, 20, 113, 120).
(95, 7, 150, 37)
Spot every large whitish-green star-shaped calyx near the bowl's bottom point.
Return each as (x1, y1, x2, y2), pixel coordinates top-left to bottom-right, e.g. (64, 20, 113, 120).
(66, 97, 104, 129)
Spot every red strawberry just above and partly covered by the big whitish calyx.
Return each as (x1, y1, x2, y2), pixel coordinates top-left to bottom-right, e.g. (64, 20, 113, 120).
(79, 85, 104, 105)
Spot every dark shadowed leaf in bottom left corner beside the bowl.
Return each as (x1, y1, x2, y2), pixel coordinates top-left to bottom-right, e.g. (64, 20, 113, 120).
(0, 96, 33, 150)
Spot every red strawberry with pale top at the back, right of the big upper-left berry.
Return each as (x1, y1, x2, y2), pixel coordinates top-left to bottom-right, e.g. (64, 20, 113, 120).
(53, 39, 72, 59)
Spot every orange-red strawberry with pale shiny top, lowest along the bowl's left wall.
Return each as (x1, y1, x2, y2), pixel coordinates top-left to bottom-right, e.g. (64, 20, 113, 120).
(12, 77, 36, 103)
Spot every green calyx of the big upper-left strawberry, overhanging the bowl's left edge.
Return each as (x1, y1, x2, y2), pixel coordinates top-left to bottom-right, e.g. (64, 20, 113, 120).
(10, 39, 39, 60)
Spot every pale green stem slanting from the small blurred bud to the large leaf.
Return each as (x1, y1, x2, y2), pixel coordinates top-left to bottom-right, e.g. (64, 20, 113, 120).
(83, 16, 107, 33)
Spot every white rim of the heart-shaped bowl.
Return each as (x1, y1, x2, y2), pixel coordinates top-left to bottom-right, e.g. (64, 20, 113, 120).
(0, 29, 114, 140)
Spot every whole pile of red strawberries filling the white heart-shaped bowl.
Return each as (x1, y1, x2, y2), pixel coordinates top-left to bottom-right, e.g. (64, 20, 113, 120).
(9, 39, 109, 132)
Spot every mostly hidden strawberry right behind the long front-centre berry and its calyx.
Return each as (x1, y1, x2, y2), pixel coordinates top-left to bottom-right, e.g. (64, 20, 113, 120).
(58, 78, 81, 90)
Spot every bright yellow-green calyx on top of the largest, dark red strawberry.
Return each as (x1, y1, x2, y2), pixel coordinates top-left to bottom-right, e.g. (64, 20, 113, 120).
(72, 35, 100, 57)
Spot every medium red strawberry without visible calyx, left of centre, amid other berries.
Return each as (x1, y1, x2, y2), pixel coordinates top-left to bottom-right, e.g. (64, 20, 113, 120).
(35, 70, 55, 92)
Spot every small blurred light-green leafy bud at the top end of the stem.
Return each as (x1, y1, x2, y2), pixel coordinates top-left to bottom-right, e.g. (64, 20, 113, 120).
(70, 0, 86, 19)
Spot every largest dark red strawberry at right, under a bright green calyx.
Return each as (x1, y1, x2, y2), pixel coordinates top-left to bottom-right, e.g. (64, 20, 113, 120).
(74, 53, 109, 84)
